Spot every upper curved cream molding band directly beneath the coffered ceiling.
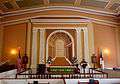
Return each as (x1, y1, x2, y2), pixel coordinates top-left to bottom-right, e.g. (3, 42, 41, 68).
(3, 6, 117, 17)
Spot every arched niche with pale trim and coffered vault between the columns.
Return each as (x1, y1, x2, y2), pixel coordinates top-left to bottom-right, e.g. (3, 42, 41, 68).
(46, 30, 74, 65)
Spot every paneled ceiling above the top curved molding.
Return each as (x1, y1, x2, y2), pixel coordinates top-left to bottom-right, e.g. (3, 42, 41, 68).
(0, 0, 120, 14)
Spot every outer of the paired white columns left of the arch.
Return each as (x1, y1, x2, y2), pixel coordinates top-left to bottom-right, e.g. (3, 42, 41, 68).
(31, 29, 38, 68)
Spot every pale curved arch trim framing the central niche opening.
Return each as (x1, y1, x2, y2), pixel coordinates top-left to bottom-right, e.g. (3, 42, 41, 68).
(46, 30, 75, 60)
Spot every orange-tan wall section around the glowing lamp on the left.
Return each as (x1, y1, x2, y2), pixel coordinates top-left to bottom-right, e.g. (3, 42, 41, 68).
(3, 23, 26, 63)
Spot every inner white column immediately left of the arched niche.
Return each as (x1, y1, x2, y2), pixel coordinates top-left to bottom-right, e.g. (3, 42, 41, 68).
(39, 29, 45, 64)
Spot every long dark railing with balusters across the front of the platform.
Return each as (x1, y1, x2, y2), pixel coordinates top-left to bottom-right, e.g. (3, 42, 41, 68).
(16, 68, 108, 79)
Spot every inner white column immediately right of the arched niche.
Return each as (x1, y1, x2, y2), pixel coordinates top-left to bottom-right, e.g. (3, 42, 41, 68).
(76, 28, 83, 63)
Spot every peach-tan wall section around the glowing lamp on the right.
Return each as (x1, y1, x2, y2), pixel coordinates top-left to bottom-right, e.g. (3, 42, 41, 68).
(93, 23, 117, 67)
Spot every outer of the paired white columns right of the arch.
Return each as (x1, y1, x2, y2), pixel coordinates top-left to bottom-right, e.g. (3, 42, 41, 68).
(83, 28, 91, 64)
